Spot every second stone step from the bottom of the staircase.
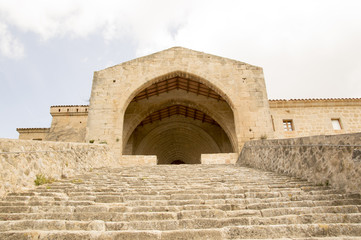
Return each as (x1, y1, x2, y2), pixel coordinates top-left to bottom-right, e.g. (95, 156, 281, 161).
(0, 214, 361, 231)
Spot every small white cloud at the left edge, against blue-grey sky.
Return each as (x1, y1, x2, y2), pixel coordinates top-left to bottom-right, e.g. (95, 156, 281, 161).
(0, 22, 24, 59)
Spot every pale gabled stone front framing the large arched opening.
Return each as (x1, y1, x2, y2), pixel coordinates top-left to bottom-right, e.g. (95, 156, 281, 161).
(86, 47, 273, 161)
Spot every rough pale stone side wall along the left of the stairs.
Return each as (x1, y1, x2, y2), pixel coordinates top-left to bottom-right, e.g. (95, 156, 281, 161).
(0, 139, 119, 197)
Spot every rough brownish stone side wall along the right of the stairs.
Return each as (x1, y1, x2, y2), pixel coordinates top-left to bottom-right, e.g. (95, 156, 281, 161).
(237, 133, 361, 193)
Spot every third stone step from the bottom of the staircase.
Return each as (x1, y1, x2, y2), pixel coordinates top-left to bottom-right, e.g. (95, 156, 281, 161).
(0, 205, 361, 221)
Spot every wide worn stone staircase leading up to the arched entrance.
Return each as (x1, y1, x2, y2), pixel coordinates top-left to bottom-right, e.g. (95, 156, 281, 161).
(0, 165, 361, 240)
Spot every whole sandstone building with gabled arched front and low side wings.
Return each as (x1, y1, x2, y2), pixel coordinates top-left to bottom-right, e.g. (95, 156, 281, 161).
(17, 47, 361, 164)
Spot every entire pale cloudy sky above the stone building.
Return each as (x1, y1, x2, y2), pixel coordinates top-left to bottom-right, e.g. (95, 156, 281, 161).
(0, 0, 361, 138)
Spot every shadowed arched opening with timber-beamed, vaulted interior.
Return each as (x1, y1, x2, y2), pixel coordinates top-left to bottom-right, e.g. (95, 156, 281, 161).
(123, 73, 237, 164)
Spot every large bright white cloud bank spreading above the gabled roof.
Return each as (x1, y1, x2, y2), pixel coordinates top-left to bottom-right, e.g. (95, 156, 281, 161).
(0, 0, 361, 97)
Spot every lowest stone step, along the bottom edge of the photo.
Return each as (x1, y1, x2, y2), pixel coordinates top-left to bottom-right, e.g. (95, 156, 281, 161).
(0, 224, 361, 240)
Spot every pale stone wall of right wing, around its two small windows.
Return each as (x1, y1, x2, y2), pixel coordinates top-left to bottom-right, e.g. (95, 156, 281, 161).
(269, 98, 361, 138)
